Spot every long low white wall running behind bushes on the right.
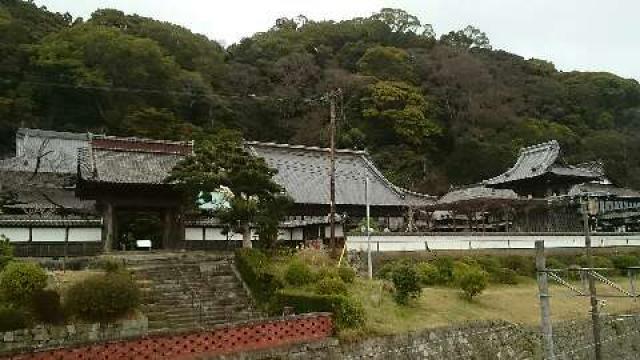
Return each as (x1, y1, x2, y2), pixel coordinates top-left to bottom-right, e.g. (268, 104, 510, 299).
(347, 233, 640, 252)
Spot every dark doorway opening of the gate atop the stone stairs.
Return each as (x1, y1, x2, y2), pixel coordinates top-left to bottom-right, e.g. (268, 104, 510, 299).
(114, 210, 164, 250)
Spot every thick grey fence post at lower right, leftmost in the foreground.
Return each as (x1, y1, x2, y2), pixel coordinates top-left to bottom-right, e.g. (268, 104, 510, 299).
(536, 241, 556, 360)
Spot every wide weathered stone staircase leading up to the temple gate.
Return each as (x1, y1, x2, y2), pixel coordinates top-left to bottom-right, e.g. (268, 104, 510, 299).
(117, 252, 260, 333)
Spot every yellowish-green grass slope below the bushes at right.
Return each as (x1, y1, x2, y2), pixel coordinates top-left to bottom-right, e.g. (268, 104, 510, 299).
(352, 278, 640, 334)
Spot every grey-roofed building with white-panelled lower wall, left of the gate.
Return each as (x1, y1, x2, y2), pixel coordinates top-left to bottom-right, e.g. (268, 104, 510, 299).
(0, 129, 102, 256)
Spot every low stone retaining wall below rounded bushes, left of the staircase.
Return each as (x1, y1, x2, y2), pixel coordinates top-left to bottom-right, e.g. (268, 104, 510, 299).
(0, 317, 148, 356)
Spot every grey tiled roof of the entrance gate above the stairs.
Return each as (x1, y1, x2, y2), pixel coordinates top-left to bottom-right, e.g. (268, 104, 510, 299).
(79, 137, 193, 184)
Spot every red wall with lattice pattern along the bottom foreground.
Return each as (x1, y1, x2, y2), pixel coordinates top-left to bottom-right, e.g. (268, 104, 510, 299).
(9, 314, 333, 360)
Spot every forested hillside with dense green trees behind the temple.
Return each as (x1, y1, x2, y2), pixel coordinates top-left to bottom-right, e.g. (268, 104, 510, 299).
(0, 0, 640, 193)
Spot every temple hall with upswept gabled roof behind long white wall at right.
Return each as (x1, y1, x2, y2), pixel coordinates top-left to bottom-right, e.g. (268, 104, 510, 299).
(430, 141, 640, 232)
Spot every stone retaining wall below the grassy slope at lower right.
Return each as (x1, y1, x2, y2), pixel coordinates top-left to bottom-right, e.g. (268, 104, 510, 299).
(212, 316, 640, 360)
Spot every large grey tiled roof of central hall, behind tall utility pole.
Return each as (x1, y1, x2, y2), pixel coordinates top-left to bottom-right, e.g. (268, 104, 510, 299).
(246, 142, 433, 206)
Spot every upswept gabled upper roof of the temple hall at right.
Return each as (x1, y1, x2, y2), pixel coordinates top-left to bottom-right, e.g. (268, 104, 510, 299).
(483, 140, 604, 198)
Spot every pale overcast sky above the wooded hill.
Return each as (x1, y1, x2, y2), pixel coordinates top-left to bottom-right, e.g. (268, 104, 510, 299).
(36, 0, 640, 80)
